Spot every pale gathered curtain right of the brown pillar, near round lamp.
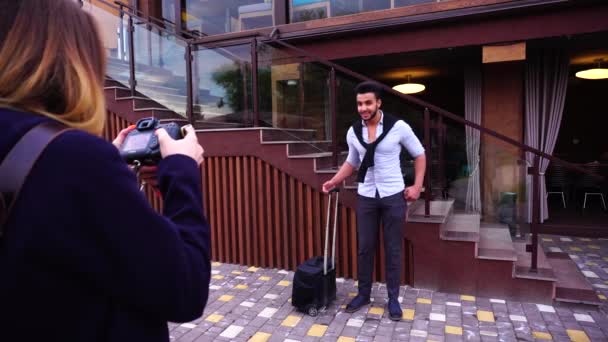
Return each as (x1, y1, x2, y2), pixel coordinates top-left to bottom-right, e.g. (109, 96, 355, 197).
(525, 49, 569, 222)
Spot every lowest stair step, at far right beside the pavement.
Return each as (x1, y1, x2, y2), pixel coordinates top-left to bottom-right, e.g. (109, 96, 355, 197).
(547, 253, 602, 306)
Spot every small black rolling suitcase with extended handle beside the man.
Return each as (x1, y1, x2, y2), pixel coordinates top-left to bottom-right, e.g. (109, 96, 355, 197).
(291, 189, 340, 317)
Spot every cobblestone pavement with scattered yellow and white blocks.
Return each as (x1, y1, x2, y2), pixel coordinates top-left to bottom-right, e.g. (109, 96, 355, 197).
(169, 237, 608, 342)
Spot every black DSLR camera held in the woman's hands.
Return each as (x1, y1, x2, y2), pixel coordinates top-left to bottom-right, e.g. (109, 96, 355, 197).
(120, 118, 182, 165)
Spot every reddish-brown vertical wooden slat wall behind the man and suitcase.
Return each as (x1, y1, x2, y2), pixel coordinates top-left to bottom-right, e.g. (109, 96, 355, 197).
(203, 156, 410, 283)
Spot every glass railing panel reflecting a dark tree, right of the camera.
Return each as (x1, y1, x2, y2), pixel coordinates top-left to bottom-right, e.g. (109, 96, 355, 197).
(193, 44, 253, 128)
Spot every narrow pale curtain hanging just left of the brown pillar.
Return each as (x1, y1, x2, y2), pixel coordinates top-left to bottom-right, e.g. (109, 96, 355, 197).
(464, 65, 481, 213)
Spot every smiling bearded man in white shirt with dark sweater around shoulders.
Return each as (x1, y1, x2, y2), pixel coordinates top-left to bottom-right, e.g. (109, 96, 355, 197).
(323, 82, 426, 321)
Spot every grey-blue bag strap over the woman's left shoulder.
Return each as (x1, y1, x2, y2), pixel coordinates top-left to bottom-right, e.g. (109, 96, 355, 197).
(0, 121, 71, 237)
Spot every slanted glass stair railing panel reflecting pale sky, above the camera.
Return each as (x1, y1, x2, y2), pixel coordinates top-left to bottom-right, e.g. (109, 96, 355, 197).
(133, 21, 188, 118)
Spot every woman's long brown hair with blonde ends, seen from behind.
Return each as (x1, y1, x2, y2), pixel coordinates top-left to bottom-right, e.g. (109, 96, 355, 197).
(0, 0, 106, 135)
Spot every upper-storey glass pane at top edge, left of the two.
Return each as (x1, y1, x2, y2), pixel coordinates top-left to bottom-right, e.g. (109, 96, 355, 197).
(182, 0, 274, 34)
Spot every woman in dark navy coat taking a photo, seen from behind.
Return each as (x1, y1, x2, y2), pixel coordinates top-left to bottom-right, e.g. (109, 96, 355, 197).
(0, 0, 210, 342)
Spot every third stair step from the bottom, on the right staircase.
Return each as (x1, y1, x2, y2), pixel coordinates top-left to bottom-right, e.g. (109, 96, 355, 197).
(477, 223, 517, 261)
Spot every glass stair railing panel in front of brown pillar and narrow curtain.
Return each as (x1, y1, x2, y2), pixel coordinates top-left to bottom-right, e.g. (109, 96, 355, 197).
(429, 115, 531, 239)
